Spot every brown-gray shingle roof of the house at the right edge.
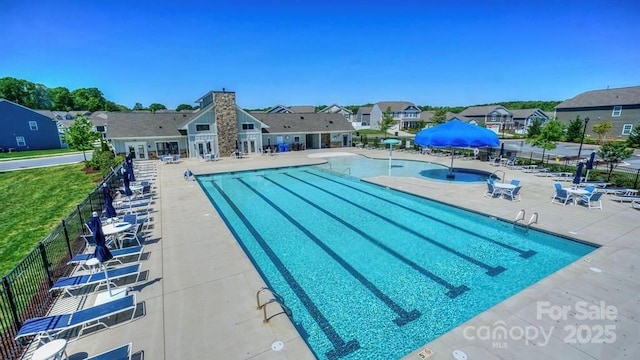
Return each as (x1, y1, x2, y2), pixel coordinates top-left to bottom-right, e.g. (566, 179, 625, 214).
(556, 86, 640, 109)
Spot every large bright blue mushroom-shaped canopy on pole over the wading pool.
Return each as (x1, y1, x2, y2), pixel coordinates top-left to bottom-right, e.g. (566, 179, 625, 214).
(414, 119, 500, 177)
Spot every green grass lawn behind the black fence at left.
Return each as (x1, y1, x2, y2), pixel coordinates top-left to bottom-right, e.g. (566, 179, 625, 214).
(0, 164, 101, 275)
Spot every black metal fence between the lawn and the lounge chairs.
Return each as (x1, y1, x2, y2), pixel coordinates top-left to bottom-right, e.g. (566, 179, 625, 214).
(0, 168, 121, 359)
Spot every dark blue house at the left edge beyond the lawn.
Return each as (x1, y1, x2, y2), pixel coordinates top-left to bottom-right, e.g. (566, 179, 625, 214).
(0, 99, 62, 151)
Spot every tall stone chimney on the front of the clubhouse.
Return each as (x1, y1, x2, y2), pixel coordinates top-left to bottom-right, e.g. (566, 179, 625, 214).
(213, 88, 238, 156)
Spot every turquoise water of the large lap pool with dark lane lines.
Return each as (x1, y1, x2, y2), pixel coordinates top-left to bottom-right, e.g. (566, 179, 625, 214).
(198, 167, 594, 359)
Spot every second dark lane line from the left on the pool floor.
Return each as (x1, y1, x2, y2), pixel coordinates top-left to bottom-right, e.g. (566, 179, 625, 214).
(237, 178, 421, 326)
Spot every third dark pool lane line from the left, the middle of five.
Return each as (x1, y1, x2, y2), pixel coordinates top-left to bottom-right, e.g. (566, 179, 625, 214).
(264, 177, 469, 299)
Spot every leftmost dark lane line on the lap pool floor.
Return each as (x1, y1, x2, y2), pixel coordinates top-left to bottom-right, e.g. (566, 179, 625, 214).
(211, 181, 360, 359)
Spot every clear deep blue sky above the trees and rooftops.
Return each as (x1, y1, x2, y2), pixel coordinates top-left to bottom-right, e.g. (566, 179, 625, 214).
(0, 0, 640, 108)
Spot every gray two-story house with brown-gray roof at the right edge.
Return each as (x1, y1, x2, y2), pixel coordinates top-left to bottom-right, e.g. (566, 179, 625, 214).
(555, 86, 640, 138)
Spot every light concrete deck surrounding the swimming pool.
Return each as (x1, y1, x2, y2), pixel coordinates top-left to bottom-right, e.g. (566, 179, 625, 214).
(61, 148, 640, 359)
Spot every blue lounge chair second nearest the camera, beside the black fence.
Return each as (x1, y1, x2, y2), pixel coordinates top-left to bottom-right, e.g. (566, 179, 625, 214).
(15, 294, 136, 340)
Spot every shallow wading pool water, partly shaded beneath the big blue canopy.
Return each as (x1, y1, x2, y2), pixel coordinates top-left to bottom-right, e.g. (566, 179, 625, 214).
(319, 155, 491, 183)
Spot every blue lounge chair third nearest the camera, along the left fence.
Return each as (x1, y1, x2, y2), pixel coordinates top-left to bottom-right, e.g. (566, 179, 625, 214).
(49, 264, 140, 296)
